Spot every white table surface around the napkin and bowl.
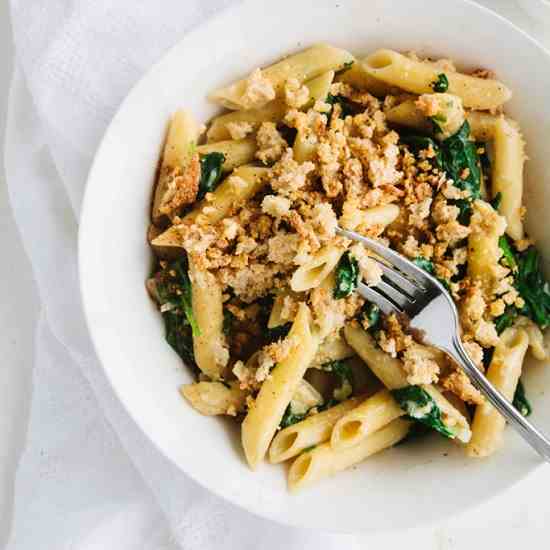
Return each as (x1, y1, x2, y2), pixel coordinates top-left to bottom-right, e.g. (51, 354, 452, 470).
(0, 0, 550, 550)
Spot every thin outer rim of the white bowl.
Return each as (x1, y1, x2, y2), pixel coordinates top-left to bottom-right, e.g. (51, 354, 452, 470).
(77, 0, 550, 534)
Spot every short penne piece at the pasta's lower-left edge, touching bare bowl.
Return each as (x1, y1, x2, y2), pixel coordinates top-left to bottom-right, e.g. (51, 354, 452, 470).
(180, 382, 247, 416)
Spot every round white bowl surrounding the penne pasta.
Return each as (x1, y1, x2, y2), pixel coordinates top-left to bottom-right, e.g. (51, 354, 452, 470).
(80, 0, 550, 531)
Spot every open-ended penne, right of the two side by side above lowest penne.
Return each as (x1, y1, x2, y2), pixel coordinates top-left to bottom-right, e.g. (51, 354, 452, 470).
(330, 389, 405, 450)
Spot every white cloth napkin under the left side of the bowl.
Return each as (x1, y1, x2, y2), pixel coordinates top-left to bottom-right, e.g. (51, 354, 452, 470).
(6, 0, 550, 550)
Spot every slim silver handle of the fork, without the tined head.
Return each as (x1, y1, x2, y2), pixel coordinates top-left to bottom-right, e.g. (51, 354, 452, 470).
(448, 339, 550, 462)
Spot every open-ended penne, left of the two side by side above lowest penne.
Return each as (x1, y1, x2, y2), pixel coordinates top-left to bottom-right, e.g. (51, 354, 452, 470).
(269, 397, 361, 464)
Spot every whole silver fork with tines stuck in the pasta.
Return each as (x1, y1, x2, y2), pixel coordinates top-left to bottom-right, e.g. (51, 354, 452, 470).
(337, 228, 550, 462)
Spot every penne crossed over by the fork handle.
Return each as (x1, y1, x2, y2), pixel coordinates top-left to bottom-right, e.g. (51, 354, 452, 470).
(466, 328, 529, 457)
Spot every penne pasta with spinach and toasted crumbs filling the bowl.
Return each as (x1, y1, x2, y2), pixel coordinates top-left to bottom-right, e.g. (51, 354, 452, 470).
(147, 44, 550, 490)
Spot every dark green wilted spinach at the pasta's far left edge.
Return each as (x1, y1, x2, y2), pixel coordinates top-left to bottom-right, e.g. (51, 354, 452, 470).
(155, 257, 200, 363)
